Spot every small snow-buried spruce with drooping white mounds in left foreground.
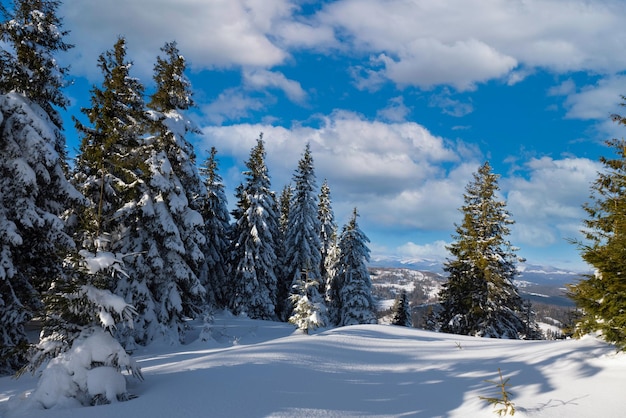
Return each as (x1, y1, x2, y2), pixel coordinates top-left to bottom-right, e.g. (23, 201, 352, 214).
(21, 250, 142, 409)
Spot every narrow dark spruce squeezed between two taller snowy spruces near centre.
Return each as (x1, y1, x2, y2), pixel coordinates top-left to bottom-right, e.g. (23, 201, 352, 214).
(275, 184, 293, 321)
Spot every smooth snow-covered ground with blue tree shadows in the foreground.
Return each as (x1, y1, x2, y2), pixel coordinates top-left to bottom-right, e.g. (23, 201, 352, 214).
(0, 315, 626, 418)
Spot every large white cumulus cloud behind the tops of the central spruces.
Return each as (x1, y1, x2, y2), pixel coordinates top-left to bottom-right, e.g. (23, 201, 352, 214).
(201, 111, 472, 229)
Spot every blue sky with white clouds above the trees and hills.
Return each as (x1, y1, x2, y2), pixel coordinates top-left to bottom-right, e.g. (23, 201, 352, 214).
(40, 0, 626, 269)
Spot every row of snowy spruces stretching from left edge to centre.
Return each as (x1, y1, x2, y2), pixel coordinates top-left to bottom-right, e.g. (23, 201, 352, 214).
(0, 1, 375, 378)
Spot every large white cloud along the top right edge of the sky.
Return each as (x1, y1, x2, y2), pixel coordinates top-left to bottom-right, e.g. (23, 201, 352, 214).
(318, 0, 626, 90)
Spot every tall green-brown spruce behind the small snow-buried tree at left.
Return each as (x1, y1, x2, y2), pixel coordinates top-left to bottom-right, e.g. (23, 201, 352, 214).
(74, 38, 148, 241)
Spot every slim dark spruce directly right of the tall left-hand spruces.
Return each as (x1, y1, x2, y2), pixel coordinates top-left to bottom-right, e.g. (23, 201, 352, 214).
(200, 147, 230, 309)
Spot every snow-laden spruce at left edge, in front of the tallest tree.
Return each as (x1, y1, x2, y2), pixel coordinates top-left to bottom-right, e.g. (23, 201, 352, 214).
(0, 93, 82, 373)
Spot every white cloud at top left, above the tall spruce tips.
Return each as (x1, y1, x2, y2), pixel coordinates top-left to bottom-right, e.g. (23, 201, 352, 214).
(60, 0, 293, 80)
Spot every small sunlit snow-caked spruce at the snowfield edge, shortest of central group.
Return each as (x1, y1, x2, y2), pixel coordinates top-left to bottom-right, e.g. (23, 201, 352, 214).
(289, 272, 327, 334)
